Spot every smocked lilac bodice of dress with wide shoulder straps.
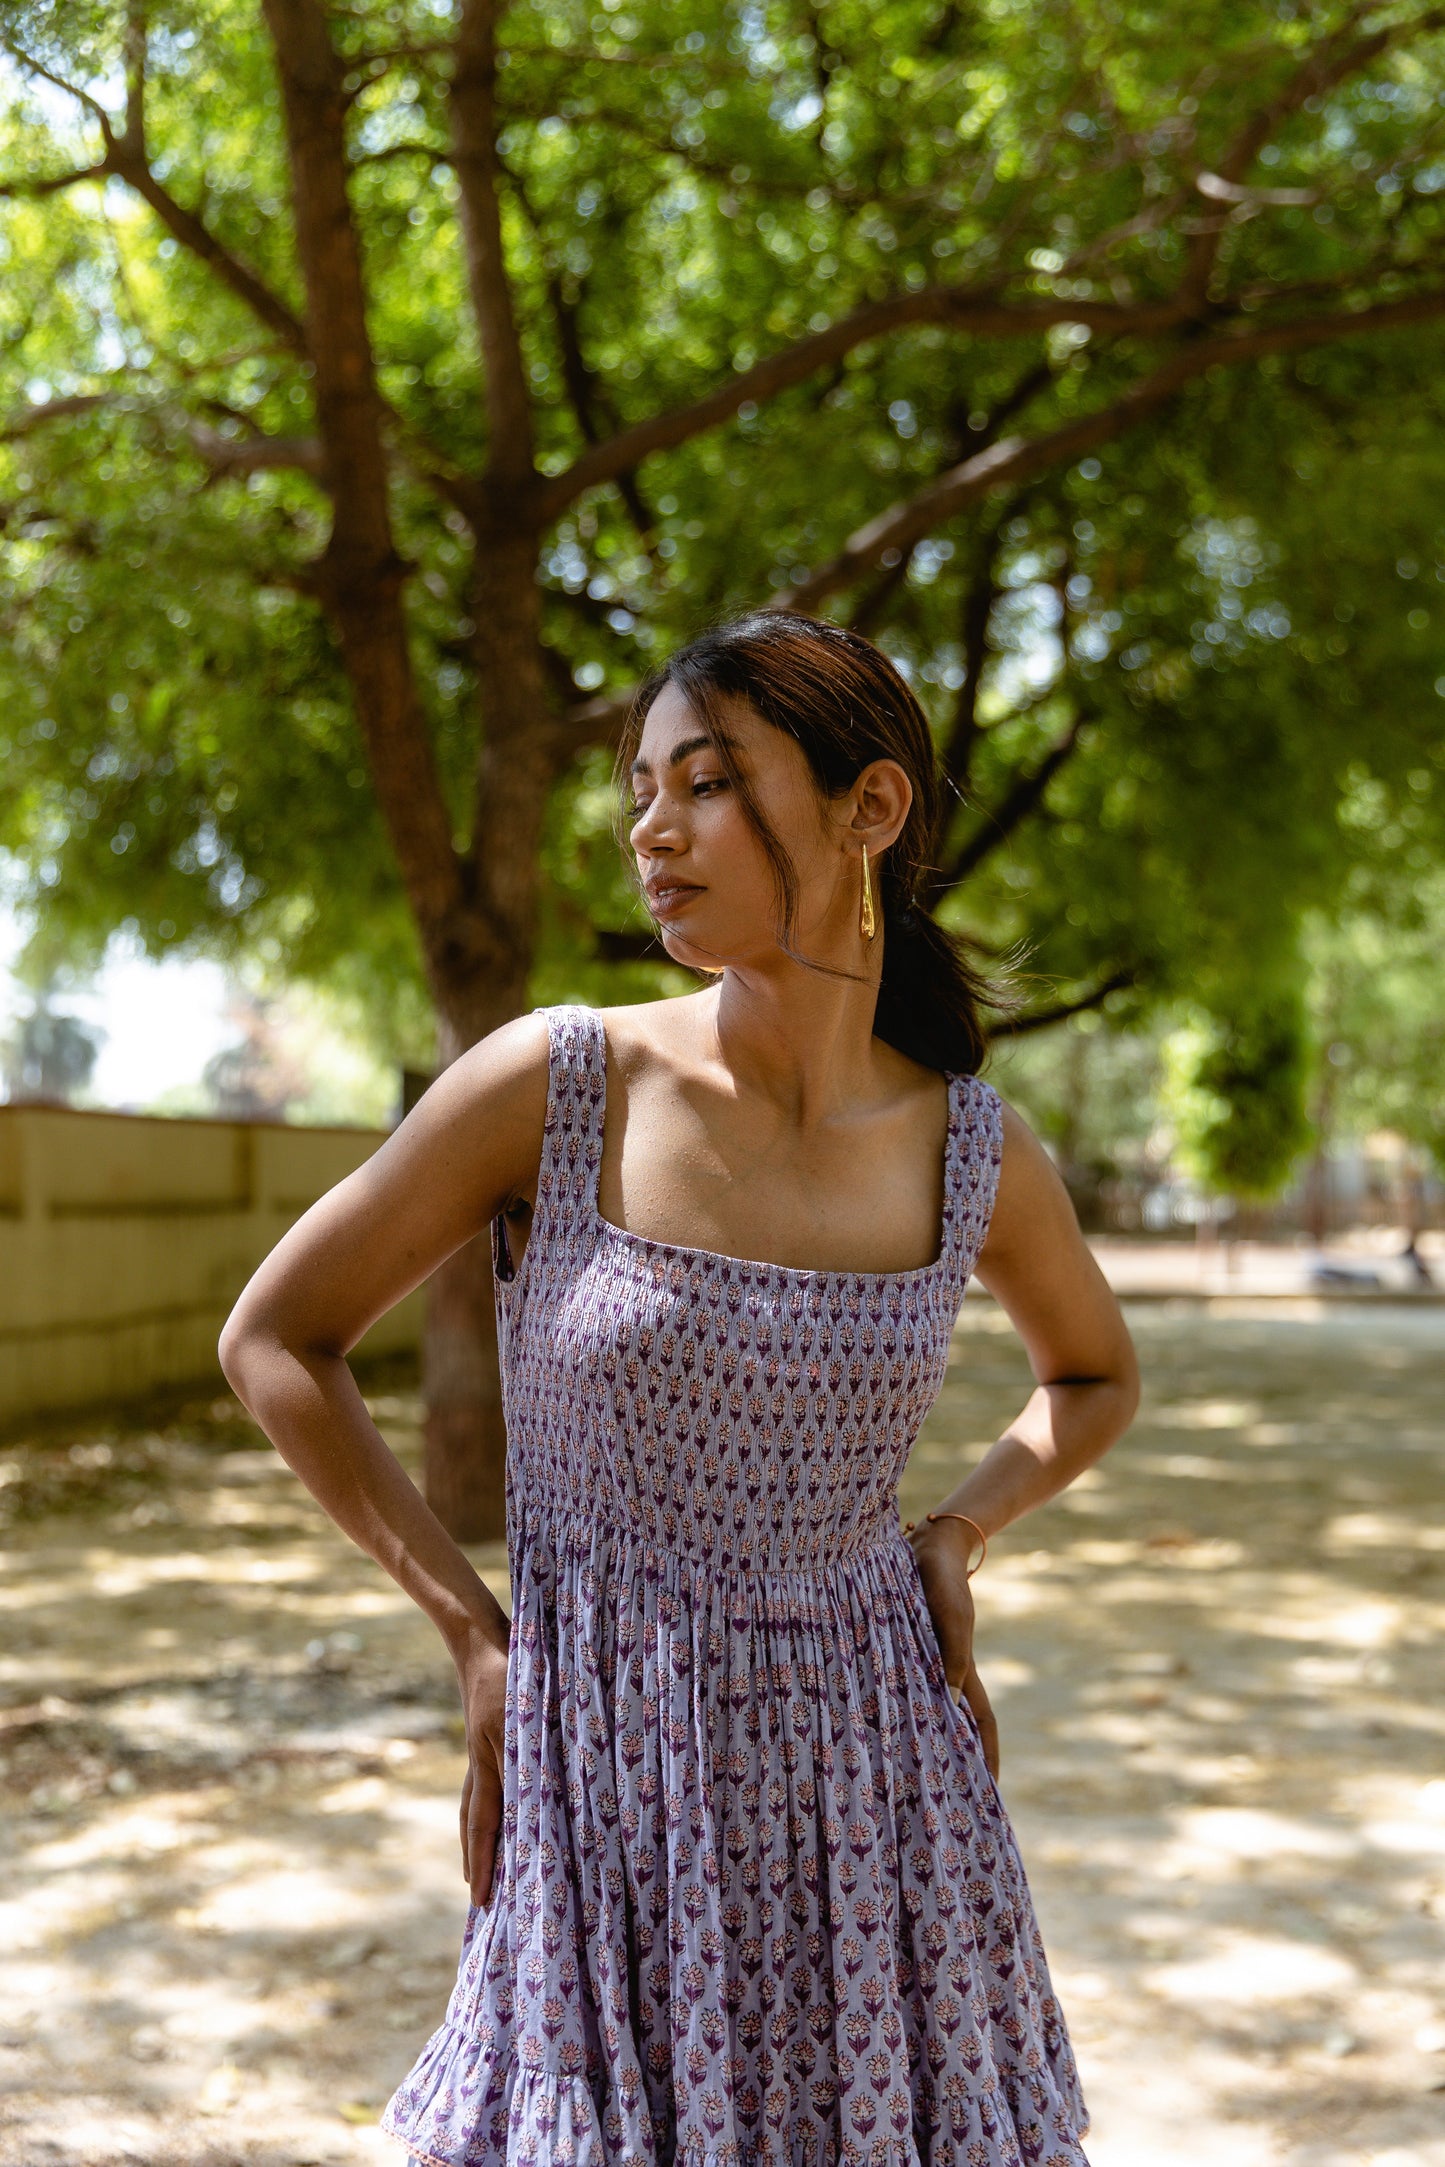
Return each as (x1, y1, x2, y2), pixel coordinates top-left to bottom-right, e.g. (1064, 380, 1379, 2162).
(494, 1005, 1001, 1573)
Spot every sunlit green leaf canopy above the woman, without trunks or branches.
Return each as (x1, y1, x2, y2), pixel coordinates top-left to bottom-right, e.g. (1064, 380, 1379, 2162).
(0, 0, 1445, 1100)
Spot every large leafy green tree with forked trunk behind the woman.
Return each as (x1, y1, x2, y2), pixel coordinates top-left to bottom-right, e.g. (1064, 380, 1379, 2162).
(0, 0, 1445, 1536)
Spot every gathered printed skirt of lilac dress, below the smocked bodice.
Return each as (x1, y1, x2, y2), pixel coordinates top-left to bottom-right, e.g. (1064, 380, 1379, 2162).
(381, 1493, 1088, 2167)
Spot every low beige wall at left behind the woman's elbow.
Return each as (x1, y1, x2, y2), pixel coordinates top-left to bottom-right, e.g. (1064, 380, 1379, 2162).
(0, 1105, 422, 1422)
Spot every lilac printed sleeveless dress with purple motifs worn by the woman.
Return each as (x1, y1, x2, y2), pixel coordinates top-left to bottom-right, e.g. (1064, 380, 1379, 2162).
(381, 1005, 1088, 2167)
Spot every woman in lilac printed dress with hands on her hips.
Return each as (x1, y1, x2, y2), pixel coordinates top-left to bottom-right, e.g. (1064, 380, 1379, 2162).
(221, 613, 1137, 2167)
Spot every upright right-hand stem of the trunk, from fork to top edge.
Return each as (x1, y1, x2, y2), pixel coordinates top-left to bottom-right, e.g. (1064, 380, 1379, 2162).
(451, 0, 535, 485)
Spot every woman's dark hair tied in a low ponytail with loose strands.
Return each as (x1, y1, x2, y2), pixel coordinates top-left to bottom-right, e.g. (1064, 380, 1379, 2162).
(613, 609, 1005, 1075)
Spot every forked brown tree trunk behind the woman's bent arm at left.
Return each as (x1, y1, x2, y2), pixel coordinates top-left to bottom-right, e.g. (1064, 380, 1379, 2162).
(264, 0, 539, 1541)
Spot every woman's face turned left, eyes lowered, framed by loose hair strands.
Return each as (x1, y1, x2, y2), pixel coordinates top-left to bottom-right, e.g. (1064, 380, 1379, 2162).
(628, 685, 875, 971)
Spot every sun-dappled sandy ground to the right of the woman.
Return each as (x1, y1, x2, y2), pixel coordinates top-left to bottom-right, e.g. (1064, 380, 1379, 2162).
(910, 1302, 1445, 2167)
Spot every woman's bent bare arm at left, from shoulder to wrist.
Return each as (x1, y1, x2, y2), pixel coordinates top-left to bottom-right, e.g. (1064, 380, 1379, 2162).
(219, 1014, 548, 1664)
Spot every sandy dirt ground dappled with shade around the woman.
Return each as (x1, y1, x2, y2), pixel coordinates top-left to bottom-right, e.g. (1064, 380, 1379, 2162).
(0, 1298, 1445, 2167)
